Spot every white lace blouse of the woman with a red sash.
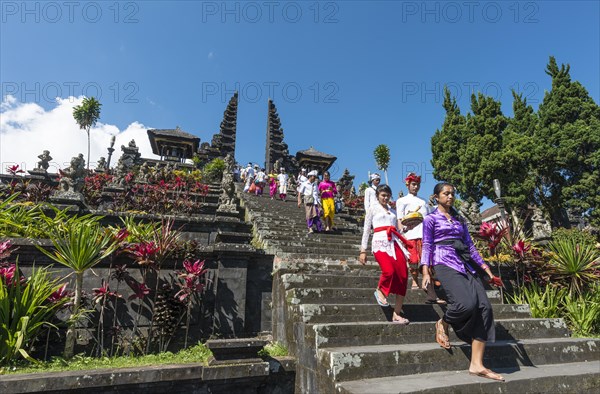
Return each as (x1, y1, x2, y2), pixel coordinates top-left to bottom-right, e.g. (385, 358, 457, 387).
(360, 202, 409, 260)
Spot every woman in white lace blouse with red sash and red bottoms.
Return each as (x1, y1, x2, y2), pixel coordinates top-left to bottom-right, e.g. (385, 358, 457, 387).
(358, 185, 409, 324)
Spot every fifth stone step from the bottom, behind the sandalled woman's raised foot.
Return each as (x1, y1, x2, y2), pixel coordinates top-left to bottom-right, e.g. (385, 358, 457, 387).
(286, 288, 500, 306)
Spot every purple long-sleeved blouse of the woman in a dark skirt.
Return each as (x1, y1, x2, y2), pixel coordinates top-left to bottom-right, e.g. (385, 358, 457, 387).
(421, 209, 488, 274)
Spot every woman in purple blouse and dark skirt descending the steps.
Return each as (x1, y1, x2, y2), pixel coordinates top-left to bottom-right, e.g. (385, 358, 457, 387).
(421, 182, 504, 381)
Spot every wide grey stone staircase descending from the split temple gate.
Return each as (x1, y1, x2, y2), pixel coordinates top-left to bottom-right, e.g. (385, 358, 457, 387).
(240, 187, 600, 393)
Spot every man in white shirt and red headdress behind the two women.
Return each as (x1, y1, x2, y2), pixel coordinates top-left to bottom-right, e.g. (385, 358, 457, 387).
(396, 172, 445, 304)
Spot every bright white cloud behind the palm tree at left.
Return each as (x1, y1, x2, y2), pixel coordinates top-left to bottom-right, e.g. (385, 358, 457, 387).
(0, 96, 159, 173)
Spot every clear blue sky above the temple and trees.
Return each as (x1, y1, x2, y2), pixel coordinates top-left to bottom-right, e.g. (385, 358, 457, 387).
(0, 1, 600, 203)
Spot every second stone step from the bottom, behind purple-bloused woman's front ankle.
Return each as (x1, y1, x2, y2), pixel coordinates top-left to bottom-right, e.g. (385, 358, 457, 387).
(319, 338, 600, 382)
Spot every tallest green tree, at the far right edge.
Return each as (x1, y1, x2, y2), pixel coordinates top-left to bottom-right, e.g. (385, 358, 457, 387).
(535, 57, 600, 226)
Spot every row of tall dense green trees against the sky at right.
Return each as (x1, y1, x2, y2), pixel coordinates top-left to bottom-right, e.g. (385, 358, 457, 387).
(431, 57, 600, 227)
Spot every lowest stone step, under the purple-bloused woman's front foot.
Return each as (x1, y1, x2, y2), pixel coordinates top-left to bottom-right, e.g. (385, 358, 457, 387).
(336, 361, 600, 394)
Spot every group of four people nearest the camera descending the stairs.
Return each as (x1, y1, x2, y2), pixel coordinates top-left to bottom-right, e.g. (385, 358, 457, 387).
(359, 173, 504, 381)
